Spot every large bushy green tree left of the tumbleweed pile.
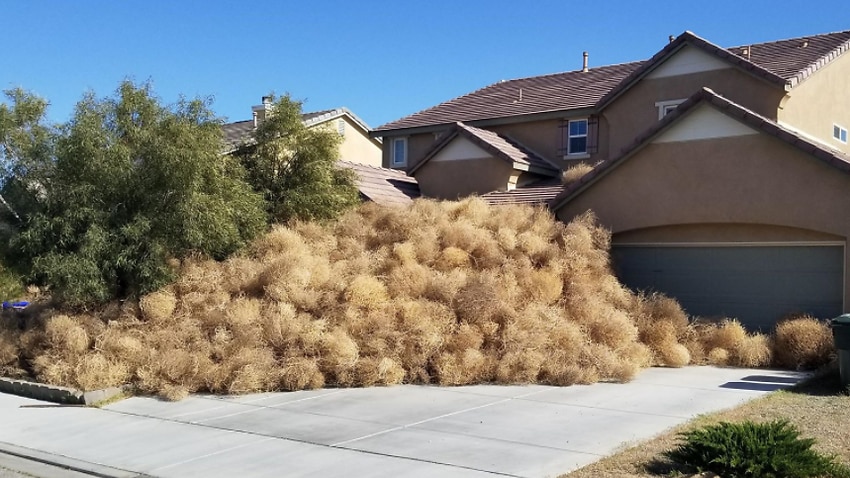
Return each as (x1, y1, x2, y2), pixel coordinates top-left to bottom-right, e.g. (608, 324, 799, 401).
(0, 81, 266, 306)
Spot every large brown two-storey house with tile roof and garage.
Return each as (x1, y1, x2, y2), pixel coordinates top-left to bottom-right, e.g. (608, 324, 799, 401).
(373, 31, 850, 328)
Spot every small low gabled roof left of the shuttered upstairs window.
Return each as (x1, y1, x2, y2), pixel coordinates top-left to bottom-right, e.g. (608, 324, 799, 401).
(408, 122, 560, 175)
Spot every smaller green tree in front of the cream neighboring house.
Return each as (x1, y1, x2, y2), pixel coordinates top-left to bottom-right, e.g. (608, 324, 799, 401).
(237, 95, 360, 222)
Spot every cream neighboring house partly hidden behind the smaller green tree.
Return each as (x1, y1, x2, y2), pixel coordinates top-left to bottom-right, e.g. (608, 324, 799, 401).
(222, 98, 419, 206)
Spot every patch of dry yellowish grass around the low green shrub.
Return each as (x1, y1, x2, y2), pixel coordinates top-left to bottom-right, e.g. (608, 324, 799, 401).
(561, 367, 850, 478)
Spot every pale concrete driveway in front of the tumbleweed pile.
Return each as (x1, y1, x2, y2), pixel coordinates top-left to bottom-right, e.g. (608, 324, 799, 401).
(0, 367, 804, 477)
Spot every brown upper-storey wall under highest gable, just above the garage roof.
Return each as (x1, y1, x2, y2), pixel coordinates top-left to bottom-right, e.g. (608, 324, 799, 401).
(602, 67, 785, 156)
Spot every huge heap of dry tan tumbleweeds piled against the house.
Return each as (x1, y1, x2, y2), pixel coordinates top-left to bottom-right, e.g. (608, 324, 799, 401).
(0, 199, 831, 399)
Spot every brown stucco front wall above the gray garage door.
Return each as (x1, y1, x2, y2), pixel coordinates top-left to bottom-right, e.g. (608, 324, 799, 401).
(557, 134, 850, 312)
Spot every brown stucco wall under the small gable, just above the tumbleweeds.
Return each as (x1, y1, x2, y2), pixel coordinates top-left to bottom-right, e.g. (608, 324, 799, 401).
(415, 157, 513, 199)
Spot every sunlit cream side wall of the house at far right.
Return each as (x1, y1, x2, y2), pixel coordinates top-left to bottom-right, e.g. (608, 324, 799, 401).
(779, 53, 850, 154)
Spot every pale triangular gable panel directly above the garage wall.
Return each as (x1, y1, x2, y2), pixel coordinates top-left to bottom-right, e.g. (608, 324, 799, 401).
(652, 104, 758, 143)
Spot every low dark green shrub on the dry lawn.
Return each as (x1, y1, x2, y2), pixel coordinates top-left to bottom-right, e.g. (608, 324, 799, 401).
(665, 420, 850, 478)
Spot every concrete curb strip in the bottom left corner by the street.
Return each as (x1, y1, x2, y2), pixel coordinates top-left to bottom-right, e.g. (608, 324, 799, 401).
(0, 442, 150, 478)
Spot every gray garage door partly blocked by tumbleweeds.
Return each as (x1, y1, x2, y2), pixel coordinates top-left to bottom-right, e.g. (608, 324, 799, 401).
(612, 246, 844, 331)
